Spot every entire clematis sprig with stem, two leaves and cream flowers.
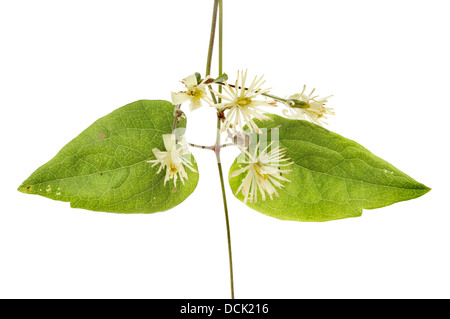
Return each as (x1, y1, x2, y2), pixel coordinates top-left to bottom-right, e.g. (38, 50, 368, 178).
(18, 0, 430, 298)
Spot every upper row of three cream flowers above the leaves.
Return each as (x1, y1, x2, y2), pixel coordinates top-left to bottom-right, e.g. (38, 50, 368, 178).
(172, 71, 334, 134)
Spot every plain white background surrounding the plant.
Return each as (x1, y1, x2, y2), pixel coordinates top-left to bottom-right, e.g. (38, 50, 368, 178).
(0, 0, 450, 298)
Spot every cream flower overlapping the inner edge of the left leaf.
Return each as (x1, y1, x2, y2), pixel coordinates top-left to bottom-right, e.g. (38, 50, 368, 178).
(147, 134, 197, 186)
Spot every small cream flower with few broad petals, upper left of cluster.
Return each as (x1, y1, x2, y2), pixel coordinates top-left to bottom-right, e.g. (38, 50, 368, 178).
(172, 74, 213, 111)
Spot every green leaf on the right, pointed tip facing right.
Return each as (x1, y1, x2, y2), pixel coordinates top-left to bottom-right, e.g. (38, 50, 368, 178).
(229, 115, 430, 221)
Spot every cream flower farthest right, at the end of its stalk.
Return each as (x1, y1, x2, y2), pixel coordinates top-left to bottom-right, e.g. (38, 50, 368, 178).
(283, 85, 334, 125)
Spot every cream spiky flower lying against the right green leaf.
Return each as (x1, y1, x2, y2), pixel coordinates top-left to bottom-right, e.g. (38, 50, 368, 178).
(231, 142, 292, 203)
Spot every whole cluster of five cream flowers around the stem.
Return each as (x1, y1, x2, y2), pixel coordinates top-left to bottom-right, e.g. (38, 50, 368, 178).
(148, 71, 334, 203)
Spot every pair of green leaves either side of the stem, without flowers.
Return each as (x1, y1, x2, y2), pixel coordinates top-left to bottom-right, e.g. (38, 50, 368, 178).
(18, 100, 429, 221)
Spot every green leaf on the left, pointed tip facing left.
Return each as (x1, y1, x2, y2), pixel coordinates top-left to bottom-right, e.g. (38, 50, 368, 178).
(18, 100, 198, 213)
